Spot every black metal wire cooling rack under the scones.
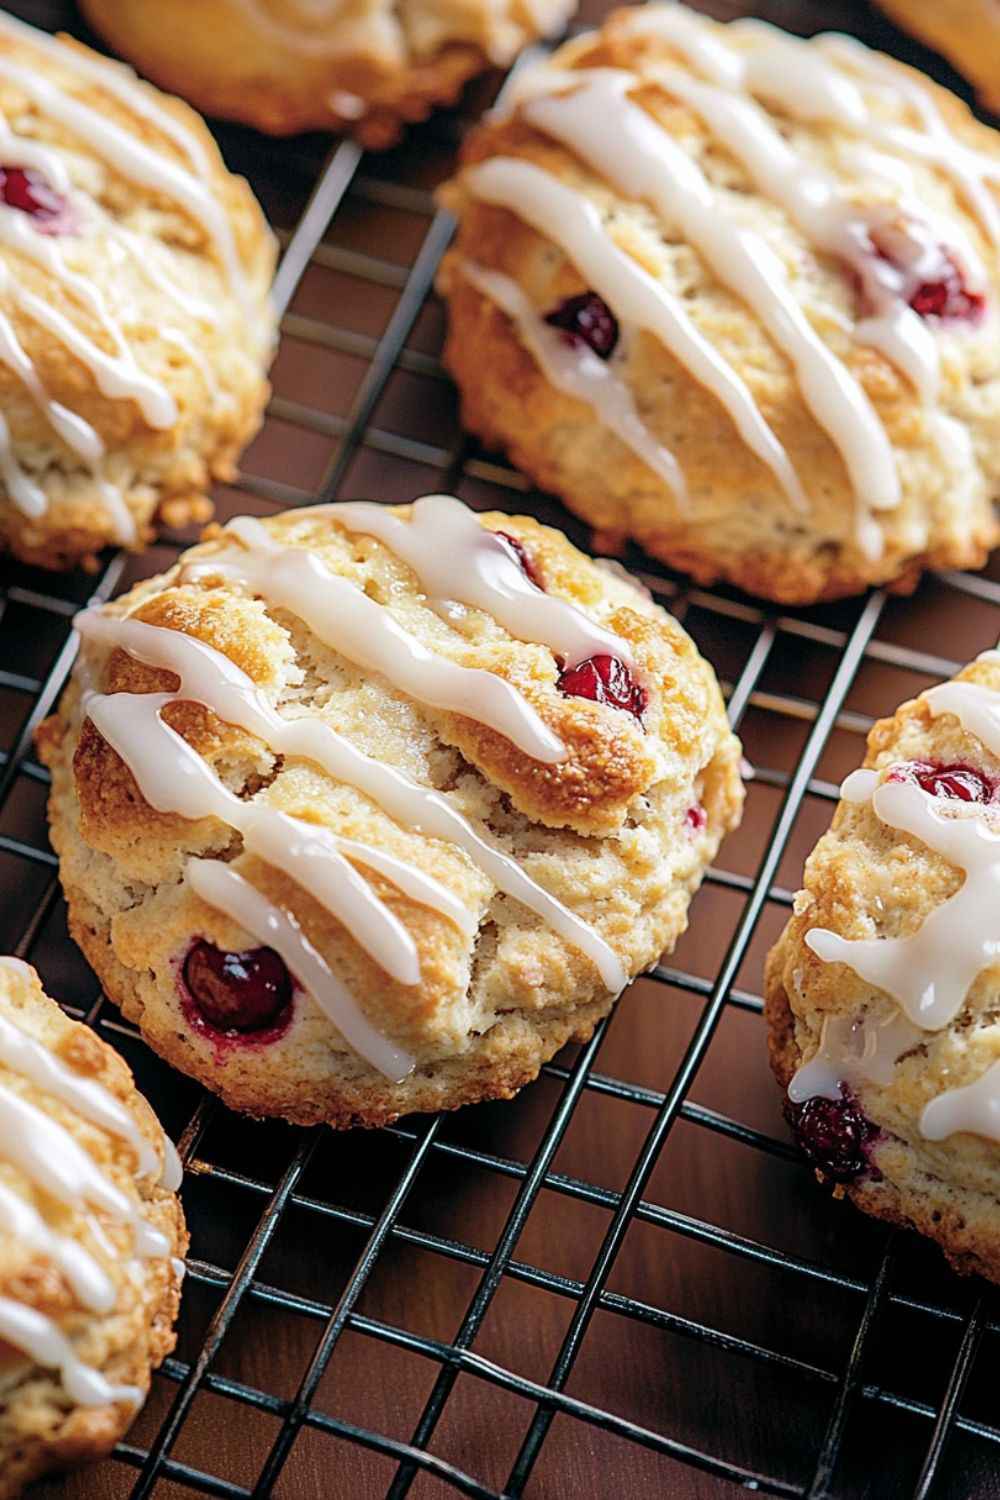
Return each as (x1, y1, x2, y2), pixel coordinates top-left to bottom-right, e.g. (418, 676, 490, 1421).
(0, 6, 1000, 1500)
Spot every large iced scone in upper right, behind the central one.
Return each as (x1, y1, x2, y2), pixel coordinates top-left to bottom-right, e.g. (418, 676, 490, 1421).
(439, 5, 1000, 603)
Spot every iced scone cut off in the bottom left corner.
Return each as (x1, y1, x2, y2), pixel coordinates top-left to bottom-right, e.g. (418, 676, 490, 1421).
(0, 959, 187, 1500)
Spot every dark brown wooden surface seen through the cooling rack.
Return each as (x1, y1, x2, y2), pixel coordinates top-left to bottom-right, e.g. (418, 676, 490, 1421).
(0, 0, 1000, 1500)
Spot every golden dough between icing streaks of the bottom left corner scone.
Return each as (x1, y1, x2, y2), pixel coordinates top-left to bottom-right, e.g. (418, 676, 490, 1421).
(0, 962, 187, 1500)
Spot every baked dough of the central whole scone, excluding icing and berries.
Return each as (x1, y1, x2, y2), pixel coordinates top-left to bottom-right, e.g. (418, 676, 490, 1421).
(39, 506, 742, 1127)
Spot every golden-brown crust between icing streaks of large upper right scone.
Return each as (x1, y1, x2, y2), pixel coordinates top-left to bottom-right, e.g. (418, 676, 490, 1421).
(439, 12, 1000, 603)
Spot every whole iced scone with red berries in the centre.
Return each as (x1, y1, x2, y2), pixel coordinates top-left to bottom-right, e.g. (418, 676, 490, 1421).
(39, 497, 742, 1127)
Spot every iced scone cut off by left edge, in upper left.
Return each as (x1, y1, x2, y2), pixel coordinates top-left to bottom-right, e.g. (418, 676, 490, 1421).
(0, 14, 274, 567)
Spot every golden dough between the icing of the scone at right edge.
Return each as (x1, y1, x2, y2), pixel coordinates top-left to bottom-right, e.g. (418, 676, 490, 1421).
(765, 653, 1000, 1281)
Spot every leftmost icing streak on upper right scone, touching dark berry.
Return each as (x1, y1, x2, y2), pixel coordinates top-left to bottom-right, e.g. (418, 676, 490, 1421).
(460, 260, 688, 504)
